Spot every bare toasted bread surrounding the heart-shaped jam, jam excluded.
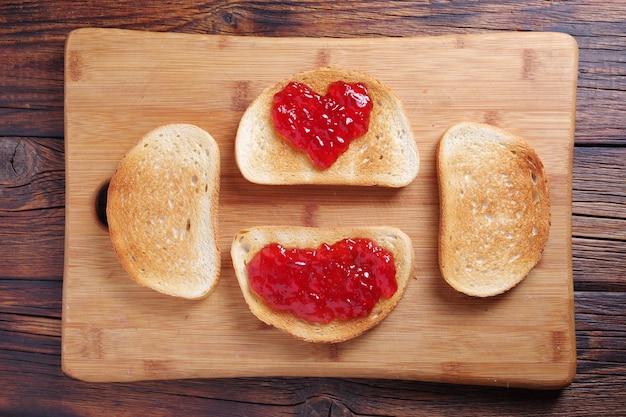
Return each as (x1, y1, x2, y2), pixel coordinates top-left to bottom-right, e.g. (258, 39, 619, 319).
(235, 67, 419, 187)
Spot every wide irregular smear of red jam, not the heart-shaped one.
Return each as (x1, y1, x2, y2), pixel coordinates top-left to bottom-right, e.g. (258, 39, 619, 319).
(247, 239, 398, 323)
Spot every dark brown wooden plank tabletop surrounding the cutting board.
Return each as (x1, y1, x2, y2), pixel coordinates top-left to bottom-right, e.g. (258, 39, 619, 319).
(0, 0, 626, 416)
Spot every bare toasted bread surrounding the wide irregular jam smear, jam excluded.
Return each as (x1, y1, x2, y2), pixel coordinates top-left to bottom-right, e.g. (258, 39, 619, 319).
(231, 226, 414, 343)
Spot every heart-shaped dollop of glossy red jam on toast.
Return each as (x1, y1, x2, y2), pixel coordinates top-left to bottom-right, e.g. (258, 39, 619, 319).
(272, 81, 373, 169)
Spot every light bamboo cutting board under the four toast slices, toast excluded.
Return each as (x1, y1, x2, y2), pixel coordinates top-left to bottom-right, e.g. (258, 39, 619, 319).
(62, 29, 578, 388)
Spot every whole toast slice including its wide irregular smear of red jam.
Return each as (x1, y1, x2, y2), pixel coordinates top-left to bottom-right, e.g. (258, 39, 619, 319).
(231, 226, 414, 343)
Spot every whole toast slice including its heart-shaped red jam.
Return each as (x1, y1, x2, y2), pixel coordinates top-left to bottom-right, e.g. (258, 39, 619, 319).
(235, 67, 419, 187)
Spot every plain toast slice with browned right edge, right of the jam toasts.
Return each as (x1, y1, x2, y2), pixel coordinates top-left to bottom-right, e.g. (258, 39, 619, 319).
(437, 123, 550, 297)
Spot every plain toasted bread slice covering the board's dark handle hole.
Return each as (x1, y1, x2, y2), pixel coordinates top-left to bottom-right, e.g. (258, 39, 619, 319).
(106, 124, 220, 299)
